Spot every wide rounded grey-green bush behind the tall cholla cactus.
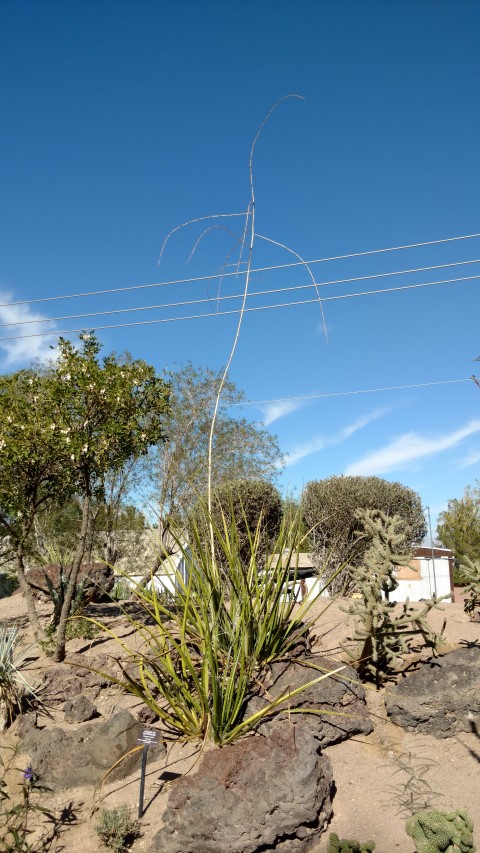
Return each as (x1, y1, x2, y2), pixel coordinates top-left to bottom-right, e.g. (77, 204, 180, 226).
(302, 477, 427, 592)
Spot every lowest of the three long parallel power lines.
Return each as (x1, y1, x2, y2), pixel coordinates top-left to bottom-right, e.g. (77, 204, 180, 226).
(0, 275, 480, 341)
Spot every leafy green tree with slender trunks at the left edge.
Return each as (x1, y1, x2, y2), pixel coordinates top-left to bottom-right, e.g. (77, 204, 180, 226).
(0, 334, 168, 660)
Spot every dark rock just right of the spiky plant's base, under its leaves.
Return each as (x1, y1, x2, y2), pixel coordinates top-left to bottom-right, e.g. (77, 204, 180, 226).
(244, 656, 373, 747)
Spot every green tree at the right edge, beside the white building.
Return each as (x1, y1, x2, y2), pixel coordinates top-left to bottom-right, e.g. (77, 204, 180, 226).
(437, 481, 480, 579)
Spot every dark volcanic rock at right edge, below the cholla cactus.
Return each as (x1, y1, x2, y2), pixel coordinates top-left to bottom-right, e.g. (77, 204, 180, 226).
(385, 646, 480, 737)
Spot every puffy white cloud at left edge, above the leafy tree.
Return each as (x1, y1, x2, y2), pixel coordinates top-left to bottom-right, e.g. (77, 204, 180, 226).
(0, 291, 55, 367)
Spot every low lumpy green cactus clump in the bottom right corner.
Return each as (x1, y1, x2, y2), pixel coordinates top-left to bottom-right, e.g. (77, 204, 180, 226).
(405, 810, 476, 853)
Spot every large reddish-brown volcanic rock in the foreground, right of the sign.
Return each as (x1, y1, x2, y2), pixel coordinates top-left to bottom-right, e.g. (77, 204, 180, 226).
(150, 722, 333, 853)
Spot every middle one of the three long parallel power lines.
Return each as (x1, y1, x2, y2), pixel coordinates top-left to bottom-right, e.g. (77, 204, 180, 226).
(0, 258, 480, 332)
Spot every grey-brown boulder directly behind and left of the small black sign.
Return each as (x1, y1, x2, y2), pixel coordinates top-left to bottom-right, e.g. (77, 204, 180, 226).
(17, 710, 166, 790)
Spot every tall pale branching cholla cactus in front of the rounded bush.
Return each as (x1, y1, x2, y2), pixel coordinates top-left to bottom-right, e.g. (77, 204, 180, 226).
(342, 509, 441, 686)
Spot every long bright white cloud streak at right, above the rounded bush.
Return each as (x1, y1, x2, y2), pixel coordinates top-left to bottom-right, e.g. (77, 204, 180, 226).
(345, 419, 480, 475)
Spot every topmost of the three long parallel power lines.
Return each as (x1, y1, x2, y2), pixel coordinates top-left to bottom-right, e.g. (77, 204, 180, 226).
(0, 233, 480, 308)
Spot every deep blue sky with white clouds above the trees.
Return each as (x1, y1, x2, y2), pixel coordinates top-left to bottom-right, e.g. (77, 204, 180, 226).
(0, 0, 480, 532)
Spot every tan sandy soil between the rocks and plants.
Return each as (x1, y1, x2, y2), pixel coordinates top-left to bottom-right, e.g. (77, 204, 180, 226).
(0, 584, 480, 853)
